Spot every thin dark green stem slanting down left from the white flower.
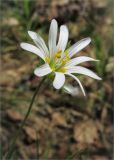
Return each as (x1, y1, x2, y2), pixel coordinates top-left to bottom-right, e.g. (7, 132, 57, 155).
(5, 77, 46, 160)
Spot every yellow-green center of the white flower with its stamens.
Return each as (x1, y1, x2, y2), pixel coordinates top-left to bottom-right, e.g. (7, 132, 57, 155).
(45, 50, 70, 73)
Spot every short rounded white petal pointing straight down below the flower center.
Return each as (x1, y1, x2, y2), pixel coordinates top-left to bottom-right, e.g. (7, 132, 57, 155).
(53, 72, 65, 89)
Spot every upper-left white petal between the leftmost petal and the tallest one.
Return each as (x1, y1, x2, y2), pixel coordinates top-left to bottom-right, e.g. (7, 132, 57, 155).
(28, 31, 49, 57)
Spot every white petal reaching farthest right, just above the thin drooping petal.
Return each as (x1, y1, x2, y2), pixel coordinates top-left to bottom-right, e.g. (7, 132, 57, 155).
(67, 66, 101, 80)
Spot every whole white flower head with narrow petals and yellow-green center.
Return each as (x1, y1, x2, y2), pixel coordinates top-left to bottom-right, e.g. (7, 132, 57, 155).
(21, 19, 101, 95)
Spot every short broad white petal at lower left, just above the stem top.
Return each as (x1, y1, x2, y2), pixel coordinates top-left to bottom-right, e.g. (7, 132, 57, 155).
(34, 63, 52, 77)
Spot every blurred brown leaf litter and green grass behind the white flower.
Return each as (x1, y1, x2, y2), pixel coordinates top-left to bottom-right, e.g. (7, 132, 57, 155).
(0, 0, 114, 160)
